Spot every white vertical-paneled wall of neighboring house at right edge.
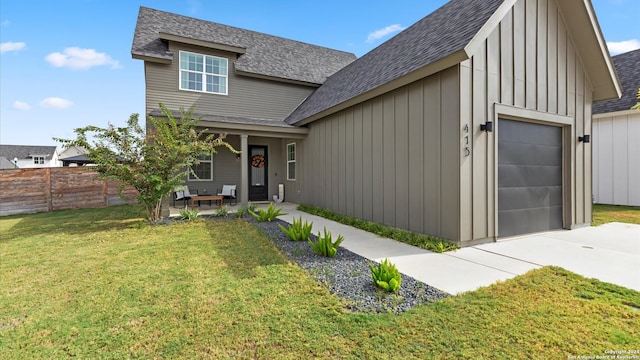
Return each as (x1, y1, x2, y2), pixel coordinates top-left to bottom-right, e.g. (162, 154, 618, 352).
(592, 111, 640, 206)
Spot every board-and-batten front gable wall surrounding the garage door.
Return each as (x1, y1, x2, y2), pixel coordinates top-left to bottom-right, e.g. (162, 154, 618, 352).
(455, 0, 592, 242)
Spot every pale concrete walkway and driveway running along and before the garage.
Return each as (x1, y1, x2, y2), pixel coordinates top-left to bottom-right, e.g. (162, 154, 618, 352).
(279, 205, 640, 295)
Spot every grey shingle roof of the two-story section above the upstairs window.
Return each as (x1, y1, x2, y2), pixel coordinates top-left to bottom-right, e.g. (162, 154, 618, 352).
(131, 7, 356, 85)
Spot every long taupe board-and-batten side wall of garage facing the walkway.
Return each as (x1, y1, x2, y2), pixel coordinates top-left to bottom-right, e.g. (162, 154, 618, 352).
(298, 66, 460, 239)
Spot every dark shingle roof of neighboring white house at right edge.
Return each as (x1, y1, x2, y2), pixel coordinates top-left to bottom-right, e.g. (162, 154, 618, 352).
(593, 49, 640, 114)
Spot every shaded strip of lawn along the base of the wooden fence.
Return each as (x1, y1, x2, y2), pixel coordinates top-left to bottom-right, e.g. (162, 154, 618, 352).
(0, 205, 145, 242)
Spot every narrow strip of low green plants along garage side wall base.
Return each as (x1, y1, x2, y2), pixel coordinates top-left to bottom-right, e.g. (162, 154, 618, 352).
(298, 204, 460, 253)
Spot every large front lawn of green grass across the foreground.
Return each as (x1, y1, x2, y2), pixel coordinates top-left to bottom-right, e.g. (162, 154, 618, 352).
(0, 206, 640, 359)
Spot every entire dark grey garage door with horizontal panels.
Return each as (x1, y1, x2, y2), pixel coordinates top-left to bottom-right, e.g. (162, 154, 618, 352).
(498, 119, 563, 237)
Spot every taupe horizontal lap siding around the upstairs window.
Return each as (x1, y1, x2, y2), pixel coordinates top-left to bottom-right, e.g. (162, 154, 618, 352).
(144, 42, 315, 120)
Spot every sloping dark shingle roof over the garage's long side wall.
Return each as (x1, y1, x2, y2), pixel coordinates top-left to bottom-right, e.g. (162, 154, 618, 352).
(286, 0, 504, 124)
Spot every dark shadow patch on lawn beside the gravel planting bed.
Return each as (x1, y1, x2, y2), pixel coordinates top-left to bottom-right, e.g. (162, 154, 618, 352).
(206, 219, 288, 279)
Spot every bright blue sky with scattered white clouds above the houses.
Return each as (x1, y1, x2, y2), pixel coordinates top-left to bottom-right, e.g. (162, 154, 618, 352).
(0, 0, 640, 145)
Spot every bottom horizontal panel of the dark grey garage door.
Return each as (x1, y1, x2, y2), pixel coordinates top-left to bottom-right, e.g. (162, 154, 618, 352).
(498, 206, 562, 237)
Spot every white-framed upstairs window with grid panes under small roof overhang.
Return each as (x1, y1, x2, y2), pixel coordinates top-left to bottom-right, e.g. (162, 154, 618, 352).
(180, 51, 228, 95)
